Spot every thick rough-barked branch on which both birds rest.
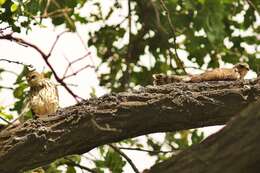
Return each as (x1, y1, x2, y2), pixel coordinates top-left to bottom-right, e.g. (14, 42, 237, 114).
(0, 79, 260, 173)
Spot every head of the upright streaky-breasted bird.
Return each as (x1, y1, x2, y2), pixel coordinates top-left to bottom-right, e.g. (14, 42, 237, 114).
(26, 71, 44, 87)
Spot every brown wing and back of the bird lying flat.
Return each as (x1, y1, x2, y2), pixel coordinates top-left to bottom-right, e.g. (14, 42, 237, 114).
(191, 68, 240, 82)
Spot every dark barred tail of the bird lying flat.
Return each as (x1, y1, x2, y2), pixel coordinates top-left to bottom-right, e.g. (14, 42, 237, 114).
(153, 74, 190, 85)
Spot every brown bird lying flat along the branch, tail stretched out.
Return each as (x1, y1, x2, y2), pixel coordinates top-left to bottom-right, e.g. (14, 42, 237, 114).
(153, 63, 249, 85)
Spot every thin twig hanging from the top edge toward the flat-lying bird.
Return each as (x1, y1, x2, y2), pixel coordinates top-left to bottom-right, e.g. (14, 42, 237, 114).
(160, 0, 187, 74)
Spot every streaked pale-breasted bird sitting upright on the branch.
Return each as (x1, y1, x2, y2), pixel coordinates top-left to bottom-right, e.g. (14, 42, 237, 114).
(20, 71, 59, 121)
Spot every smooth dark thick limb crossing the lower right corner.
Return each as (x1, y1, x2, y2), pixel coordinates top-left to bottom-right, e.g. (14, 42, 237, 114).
(149, 98, 260, 173)
